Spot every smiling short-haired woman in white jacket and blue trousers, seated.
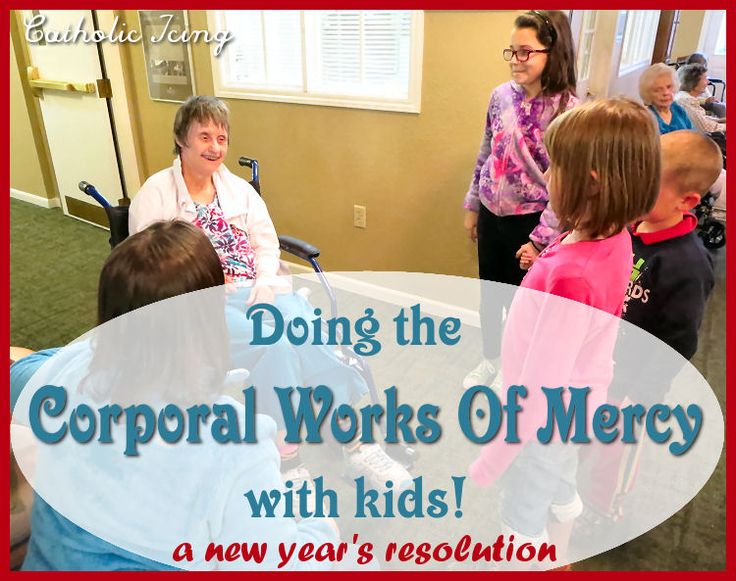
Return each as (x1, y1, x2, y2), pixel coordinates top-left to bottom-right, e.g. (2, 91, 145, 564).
(129, 96, 411, 488)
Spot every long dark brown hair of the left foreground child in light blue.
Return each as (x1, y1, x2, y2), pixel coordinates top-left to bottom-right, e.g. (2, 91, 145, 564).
(85, 220, 230, 404)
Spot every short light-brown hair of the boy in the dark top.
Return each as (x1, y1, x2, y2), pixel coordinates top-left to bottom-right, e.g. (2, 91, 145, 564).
(662, 129, 723, 196)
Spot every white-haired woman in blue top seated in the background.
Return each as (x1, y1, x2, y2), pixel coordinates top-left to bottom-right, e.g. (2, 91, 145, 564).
(639, 63, 693, 135)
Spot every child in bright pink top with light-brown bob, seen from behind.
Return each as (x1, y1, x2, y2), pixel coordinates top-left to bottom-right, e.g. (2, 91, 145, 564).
(470, 98, 660, 558)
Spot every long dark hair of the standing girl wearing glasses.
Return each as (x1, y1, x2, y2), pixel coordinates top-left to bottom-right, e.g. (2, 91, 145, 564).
(514, 10, 577, 114)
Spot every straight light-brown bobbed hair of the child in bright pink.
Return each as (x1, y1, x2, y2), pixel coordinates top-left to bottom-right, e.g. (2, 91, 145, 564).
(544, 97, 661, 238)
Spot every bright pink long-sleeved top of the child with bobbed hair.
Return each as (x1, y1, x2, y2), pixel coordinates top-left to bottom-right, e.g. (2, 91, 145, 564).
(469, 230, 632, 486)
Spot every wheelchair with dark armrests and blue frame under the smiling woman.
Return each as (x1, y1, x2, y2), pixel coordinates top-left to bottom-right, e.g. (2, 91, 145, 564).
(79, 156, 418, 469)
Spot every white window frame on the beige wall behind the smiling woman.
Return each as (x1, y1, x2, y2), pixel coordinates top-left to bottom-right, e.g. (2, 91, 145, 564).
(207, 10, 424, 113)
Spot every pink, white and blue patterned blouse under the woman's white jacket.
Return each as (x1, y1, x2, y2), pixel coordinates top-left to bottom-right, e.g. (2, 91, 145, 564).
(194, 196, 256, 282)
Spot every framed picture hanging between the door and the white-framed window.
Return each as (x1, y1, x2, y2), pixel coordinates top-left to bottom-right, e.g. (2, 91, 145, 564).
(138, 10, 194, 103)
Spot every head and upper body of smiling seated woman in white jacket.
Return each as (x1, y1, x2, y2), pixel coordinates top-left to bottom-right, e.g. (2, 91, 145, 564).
(129, 96, 280, 304)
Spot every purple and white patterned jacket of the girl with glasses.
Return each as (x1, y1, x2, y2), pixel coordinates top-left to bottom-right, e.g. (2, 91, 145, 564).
(463, 81, 579, 246)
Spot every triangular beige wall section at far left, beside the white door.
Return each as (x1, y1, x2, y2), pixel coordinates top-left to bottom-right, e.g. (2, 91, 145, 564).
(10, 42, 55, 198)
